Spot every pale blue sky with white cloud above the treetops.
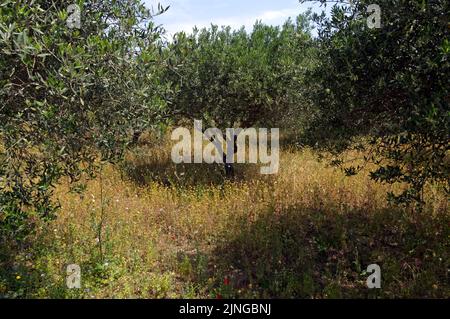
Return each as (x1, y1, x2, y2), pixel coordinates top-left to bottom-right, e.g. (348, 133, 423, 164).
(145, 0, 321, 35)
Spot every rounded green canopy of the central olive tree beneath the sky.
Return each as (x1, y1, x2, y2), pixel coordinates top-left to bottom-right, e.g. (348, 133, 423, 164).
(165, 13, 313, 128)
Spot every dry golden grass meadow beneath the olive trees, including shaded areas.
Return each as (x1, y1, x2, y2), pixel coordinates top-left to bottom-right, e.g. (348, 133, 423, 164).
(0, 137, 450, 298)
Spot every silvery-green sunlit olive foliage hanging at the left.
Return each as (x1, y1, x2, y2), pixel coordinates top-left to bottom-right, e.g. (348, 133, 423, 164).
(0, 0, 169, 245)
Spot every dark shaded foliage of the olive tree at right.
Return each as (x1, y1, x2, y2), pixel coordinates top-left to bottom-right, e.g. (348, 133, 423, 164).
(302, 0, 450, 203)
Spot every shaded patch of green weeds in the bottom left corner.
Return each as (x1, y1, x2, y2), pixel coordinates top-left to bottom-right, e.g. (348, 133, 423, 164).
(0, 230, 123, 299)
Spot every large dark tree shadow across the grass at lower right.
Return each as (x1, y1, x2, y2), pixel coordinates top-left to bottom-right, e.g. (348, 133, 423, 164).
(213, 207, 450, 298)
